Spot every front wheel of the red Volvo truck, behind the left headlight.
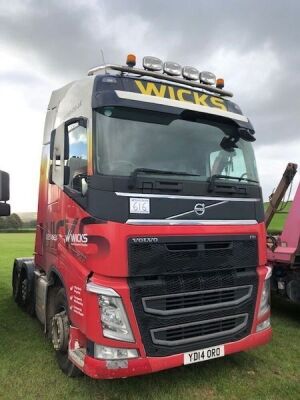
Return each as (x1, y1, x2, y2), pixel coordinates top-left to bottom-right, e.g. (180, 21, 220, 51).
(47, 287, 82, 377)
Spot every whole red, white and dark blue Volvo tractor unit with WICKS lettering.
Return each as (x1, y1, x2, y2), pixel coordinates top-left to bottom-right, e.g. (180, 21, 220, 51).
(12, 55, 271, 378)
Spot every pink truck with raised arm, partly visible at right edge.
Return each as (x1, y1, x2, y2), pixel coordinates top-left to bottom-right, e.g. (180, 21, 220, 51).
(266, 163, 300, 304)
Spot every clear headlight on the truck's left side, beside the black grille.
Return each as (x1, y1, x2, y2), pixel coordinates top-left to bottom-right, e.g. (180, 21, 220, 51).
(99, 295, 134, 342)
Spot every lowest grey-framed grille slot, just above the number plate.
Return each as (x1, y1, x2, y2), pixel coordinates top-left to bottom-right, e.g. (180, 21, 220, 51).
(151, 314, 248, 346)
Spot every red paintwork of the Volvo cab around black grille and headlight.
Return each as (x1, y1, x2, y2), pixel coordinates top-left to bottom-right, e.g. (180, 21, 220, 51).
(35, 175, 271, 378)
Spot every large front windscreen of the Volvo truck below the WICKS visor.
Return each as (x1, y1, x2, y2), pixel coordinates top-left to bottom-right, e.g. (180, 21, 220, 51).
(95, 107, 258, 184)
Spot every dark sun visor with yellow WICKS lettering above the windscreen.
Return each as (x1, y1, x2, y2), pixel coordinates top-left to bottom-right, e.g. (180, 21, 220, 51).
(92, 75, 253, 130)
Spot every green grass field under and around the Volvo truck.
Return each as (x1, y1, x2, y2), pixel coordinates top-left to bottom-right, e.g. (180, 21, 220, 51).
(0, 233, 300, 400)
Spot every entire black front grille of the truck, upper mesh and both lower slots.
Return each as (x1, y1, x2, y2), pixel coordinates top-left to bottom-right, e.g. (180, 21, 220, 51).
(128, 236, 258, 357)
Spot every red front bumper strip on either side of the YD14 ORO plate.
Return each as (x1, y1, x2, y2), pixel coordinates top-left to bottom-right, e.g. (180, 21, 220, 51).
(82, 328, 272, 379)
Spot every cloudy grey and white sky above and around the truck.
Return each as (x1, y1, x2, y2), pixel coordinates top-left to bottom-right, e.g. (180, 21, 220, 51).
(0, 0, 300, 212)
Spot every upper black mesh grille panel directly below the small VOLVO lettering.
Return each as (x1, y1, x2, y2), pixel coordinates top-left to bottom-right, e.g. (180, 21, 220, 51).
(128, 235, 257, 276)
